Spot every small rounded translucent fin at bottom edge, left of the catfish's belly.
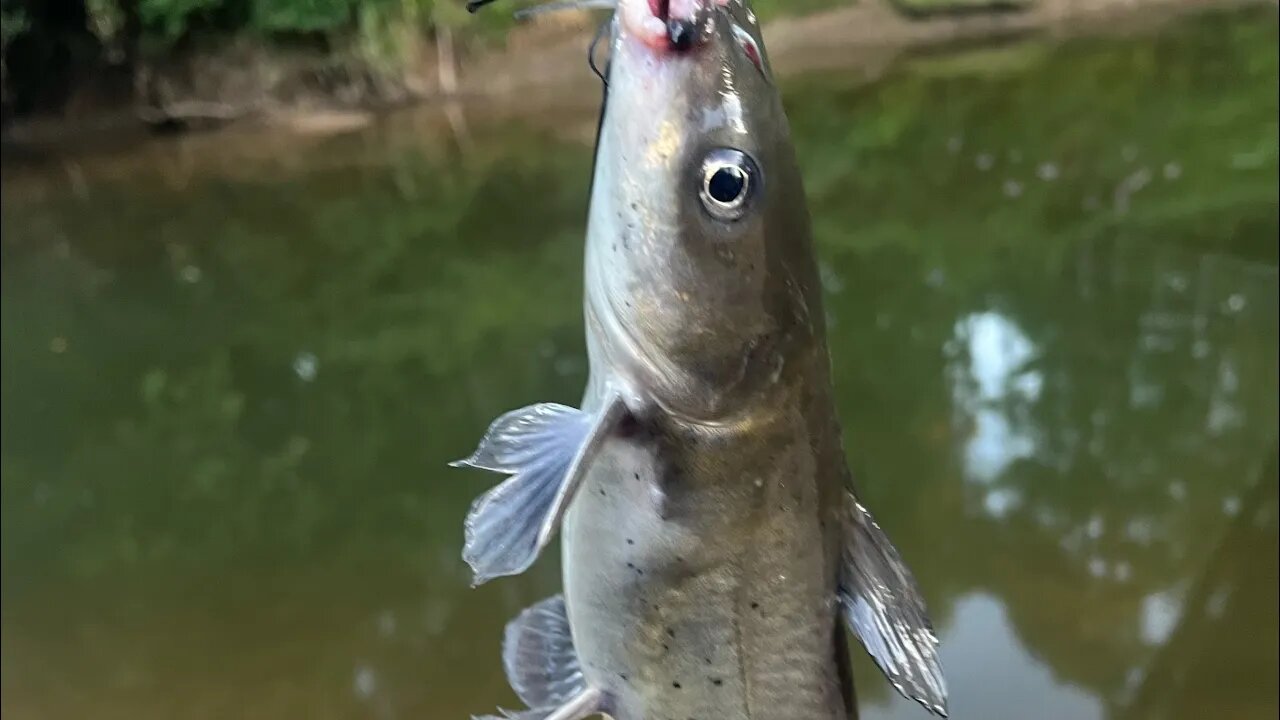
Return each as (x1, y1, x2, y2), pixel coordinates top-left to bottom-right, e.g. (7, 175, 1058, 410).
(483, 594, 604, 720)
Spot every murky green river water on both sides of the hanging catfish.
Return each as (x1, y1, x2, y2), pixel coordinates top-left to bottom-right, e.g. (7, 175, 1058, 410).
(0, 9, 1280, 720)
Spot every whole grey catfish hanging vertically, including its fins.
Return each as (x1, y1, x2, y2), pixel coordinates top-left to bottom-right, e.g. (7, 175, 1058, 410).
(462, 0, 946, 720)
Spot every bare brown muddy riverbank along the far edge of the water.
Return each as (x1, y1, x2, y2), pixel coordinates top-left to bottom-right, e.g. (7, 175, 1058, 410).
(3, 0, 1276, 155)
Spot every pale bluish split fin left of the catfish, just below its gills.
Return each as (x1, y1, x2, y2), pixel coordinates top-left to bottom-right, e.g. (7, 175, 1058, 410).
(453, 396, 626, 584)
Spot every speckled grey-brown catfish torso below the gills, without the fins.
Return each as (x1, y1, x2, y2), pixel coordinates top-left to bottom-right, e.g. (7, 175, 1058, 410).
(563, 425, 849, 720)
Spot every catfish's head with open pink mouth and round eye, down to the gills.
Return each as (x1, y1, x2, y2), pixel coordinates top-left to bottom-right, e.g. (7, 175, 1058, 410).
(588, 0, 823, 421)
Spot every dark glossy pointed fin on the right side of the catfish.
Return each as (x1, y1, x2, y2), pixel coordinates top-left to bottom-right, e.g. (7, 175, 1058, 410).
(840, 493, 947, 717)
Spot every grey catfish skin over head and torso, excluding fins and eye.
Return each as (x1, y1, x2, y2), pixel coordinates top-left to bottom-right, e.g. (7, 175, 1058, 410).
(562, 1, 852, 720)
